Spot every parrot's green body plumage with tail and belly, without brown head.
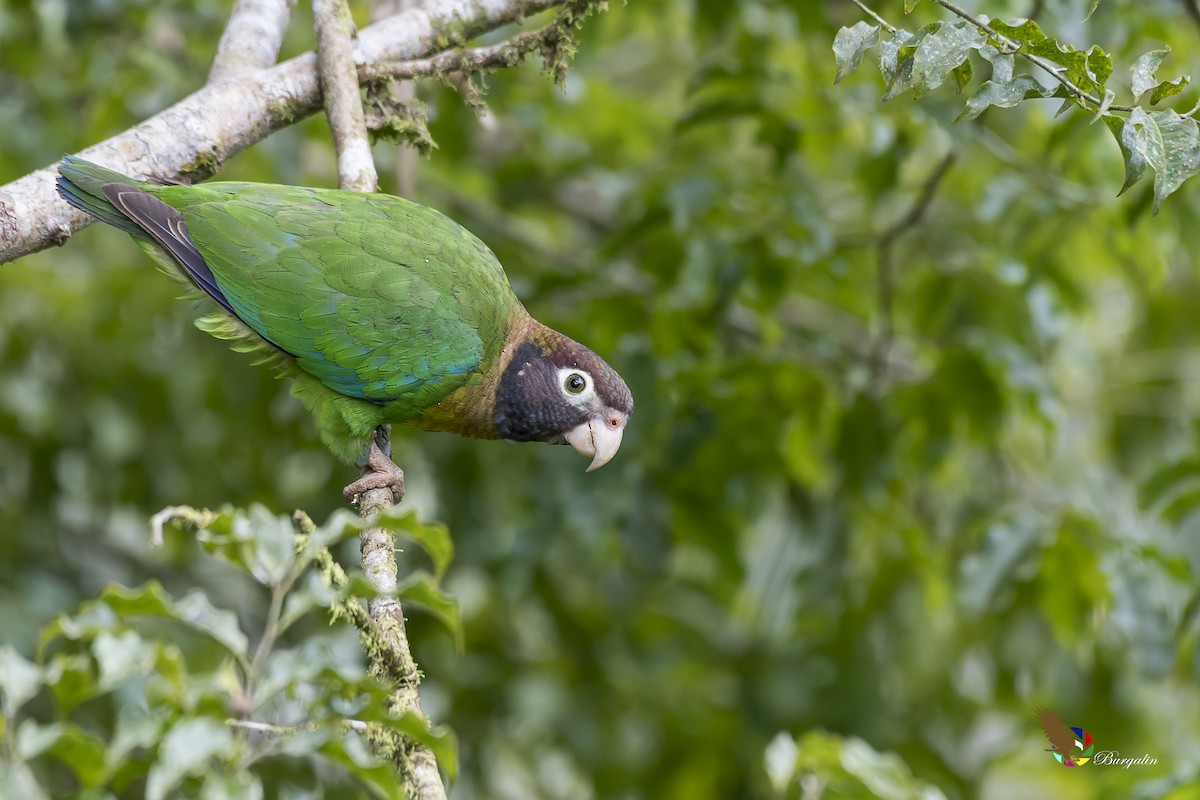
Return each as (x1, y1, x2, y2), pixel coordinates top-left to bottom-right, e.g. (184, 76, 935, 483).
(58, 156, 523, 462)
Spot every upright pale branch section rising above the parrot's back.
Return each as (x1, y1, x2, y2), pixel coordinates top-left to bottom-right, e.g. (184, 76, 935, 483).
(312, 0, 379, 192)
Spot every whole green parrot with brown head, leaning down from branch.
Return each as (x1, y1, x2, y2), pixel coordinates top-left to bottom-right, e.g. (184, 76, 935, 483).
(58, 156, 634, 498)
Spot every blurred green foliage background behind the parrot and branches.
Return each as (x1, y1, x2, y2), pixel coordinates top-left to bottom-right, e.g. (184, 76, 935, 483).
(0, 0, 1200, 800)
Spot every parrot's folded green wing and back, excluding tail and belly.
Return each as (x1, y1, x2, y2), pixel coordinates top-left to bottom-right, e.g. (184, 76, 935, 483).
(146, 184, 517, 422)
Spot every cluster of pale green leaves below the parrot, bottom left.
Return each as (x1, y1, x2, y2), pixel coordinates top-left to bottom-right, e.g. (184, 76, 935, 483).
(0, 506, 461, 800)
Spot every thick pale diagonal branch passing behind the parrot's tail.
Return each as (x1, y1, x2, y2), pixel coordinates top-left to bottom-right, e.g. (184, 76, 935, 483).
(0, 0, 560, 263)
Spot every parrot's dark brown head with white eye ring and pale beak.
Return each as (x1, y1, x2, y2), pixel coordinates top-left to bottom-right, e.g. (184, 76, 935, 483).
(492, 333, 634, 473)
